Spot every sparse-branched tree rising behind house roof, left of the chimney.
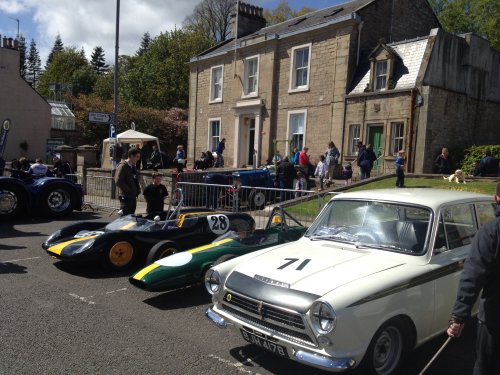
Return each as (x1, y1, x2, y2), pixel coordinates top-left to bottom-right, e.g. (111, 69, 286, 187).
(184, 0, 236, 42)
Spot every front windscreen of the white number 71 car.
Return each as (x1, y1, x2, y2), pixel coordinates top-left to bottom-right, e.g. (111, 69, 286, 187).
(306, 199, 432, 254)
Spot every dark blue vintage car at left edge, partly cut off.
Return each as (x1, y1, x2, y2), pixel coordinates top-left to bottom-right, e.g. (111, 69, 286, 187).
(0, 173, 83, 220)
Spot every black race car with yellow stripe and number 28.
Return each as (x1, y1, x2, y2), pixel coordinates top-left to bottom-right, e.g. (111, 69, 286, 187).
(42, 208, 254, 269)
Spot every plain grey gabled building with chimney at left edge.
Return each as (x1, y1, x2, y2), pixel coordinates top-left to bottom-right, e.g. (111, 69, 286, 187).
(0, 37, 51, 161)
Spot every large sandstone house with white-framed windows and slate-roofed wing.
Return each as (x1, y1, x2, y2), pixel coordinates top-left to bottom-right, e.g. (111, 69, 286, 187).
(188, 0, 500, 172)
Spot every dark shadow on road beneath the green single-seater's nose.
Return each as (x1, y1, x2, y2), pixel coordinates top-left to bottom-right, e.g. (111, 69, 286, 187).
(143, 285, 210, 310)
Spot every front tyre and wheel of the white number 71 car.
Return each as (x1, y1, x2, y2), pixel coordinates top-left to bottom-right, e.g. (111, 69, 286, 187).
(361, 318, 410, 375)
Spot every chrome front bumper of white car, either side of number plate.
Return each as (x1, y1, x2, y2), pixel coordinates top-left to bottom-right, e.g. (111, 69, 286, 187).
(205, 307, 356, 372)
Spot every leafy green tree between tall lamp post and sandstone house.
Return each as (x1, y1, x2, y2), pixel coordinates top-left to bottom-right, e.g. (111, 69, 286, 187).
(120, 29, 213, 109)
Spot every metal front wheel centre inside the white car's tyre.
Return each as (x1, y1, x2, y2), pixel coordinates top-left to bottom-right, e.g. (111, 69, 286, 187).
(373, 327, 403, 374)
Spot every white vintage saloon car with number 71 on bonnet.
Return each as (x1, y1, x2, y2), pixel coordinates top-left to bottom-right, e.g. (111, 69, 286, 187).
(205, 189, 495, 375)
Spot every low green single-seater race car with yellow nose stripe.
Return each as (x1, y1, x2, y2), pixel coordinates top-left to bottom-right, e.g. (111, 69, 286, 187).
(129, 207, 307, 292)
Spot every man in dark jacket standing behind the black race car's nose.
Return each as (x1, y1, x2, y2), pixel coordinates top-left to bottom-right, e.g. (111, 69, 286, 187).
(115, 148, 141, 215)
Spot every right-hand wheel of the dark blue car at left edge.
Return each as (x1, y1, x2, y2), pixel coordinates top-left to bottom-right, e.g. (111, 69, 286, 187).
(40, 184, 75, 216)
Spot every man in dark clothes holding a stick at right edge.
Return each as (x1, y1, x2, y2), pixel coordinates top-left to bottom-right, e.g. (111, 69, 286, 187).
(447, 183, 500, 375)
